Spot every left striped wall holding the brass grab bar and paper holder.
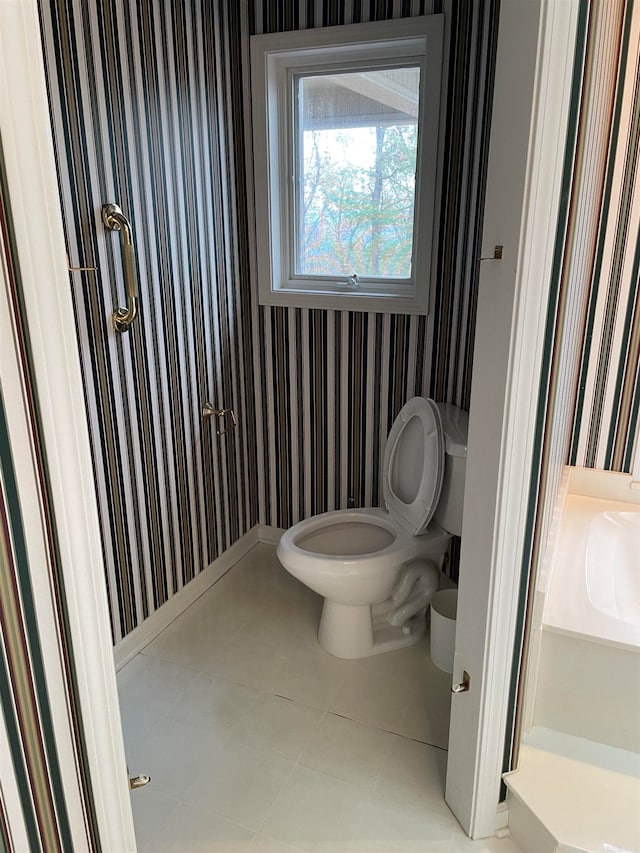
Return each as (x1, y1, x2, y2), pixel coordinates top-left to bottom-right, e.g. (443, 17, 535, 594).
(40, 0, 257, 642)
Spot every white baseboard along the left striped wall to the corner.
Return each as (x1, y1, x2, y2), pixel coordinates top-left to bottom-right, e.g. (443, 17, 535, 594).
(113, 525, 260, 671)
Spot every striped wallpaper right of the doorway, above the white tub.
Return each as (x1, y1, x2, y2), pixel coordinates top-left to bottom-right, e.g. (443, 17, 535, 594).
(505, 0, 640, 770)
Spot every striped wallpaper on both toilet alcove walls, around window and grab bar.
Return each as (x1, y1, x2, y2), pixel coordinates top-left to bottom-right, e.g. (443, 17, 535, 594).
(40, 0, 497, 642)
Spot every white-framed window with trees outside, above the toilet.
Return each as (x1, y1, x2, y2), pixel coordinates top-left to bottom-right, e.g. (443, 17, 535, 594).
(251, 15, 443, 314)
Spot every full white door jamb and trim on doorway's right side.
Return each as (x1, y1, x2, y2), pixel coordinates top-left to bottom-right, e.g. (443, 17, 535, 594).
(446, 0, 577, 838)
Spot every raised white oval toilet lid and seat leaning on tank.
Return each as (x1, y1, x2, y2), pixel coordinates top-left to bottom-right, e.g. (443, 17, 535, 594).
(382, 397, 444, 536)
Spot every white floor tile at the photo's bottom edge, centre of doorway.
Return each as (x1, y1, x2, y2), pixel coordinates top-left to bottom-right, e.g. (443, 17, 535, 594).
(259, 767, 365, 853)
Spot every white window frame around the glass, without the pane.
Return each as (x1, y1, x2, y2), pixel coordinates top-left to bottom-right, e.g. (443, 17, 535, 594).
(251, 15, 444, 314)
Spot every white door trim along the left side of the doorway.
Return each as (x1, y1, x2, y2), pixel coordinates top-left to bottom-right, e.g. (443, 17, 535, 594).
(0, 0, 136, 853)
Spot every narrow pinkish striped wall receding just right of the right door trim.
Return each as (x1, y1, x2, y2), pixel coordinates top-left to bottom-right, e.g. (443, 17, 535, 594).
(537, 0, 625, 600)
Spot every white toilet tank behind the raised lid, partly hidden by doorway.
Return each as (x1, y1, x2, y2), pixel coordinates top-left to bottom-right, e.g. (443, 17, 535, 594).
(433, 403, 469, 536)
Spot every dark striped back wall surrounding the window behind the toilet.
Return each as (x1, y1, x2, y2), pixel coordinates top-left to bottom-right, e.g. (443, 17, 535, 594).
(245, 0, 498, 527)
